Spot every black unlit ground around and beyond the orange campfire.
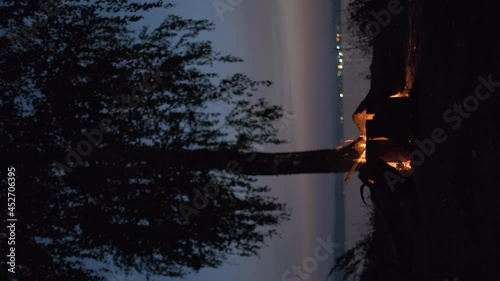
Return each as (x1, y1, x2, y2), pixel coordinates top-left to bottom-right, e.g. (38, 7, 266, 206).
(358, 0, 500, 281)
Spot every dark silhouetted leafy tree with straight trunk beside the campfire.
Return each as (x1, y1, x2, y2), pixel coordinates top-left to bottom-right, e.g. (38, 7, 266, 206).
(0, 0, 359, 280)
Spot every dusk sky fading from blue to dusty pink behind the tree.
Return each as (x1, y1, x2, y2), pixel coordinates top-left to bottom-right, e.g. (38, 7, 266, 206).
(111, 0, 376, 281)
